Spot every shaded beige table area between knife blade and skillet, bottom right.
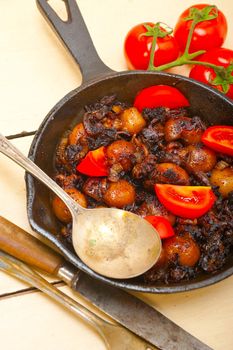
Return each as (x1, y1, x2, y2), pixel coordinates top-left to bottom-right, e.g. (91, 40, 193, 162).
(137, 276, 233, 350)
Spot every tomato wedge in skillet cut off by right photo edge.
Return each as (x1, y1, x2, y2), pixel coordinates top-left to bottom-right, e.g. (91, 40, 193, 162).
(201, 125, 233, 156)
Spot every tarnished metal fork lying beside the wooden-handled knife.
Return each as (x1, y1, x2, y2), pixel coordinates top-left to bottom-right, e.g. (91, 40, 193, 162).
(0, 251, 158, 350)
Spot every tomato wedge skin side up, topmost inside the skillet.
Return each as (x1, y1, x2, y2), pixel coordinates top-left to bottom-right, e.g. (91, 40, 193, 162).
(134, 85, 189, 112)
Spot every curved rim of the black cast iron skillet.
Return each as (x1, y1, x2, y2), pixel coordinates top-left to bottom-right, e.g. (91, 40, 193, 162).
(25, 71, 233, 294)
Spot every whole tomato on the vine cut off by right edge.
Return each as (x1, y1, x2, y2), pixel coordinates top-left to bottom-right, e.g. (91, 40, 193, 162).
(189, 47, 233, 98)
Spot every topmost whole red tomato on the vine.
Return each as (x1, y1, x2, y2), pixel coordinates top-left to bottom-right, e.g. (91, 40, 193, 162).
(174, 4, 227, 52)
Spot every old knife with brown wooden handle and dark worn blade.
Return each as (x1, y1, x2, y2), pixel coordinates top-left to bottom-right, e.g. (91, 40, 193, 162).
(0, 216, 211, 350)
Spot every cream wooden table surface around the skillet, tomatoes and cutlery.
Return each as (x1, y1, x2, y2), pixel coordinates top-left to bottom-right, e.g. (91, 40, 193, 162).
(0, 0, 233, 350)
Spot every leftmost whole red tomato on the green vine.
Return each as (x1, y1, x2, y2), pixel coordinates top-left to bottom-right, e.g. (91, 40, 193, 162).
(124, 23, 179, 69)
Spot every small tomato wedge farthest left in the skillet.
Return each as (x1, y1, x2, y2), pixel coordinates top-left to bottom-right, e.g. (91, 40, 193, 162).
(76, 146, 108, 176)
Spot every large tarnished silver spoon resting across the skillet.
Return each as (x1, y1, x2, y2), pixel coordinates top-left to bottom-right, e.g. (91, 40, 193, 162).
(0, 134, 161, 279)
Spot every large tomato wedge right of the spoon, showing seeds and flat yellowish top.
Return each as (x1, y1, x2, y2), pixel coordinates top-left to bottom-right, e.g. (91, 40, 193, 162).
(155, 184, 216, 219)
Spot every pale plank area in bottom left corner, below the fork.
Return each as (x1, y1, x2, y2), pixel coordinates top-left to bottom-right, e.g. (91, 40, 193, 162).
(0, 284, 105, 350)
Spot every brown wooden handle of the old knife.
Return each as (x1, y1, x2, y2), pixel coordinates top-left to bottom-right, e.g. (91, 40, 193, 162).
(0, 216, 64, 274)
